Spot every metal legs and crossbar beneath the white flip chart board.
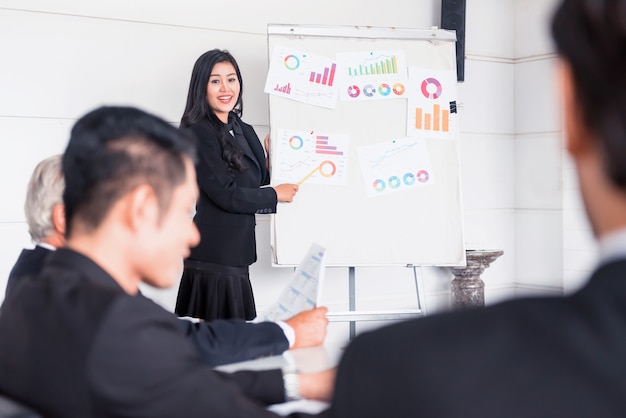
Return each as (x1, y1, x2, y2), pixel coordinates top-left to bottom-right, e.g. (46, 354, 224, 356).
(326, 264, 426, 340)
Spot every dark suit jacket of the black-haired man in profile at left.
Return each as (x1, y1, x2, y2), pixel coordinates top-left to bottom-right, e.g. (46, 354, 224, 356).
(0, 249, 320, 418)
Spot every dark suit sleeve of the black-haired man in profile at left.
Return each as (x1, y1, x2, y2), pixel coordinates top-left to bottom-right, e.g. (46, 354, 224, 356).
(85, 297, 284, 418)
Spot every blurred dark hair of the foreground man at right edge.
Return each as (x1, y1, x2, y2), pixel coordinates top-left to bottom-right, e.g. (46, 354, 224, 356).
(552, 0, 626, 189)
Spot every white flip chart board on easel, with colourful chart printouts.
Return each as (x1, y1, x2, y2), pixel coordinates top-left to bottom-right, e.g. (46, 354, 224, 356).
(266, 25, 465, 328)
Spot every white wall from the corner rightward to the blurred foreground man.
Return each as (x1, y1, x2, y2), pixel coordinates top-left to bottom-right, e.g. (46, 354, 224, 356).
(514, 0, 596, 295)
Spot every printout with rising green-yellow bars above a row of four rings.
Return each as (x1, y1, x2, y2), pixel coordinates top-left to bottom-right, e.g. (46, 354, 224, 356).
(336, 51, 407, 101)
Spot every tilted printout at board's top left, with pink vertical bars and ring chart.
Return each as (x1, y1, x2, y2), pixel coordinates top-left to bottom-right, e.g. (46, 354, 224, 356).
(264, 45, 337, 109)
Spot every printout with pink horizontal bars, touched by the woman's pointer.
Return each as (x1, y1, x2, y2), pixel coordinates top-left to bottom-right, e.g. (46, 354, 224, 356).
(272, 129, 349, 186)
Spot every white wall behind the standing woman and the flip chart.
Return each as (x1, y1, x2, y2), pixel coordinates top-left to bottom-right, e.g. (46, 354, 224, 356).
(0, 0, 594, 344)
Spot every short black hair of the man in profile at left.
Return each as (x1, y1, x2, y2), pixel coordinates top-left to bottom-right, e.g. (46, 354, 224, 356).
(63, 107, 196, 237)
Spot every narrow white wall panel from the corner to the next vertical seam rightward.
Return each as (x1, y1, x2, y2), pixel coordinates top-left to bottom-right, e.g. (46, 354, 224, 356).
(514, 1, 563, 294)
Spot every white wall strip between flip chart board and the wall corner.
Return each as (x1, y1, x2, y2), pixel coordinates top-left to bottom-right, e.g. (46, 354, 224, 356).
(459, 0, 516, 303)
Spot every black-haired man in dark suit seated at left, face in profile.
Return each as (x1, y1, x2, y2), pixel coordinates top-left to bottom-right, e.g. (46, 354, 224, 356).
(0, 107, 334, 418)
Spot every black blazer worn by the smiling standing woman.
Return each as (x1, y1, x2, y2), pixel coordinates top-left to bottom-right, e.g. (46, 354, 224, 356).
(183, 114, 277, 267)
